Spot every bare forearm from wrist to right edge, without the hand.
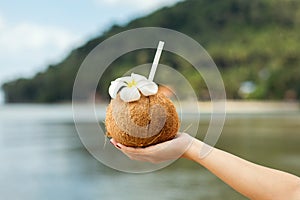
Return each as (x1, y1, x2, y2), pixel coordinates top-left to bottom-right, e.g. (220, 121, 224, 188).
(184, 140, 300, 199)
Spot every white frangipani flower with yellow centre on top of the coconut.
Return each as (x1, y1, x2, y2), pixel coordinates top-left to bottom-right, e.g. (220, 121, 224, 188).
(108, 73, 158, 102)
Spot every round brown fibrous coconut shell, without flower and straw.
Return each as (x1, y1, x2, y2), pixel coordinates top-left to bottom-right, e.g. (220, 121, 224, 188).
(105, 93, 180, 147)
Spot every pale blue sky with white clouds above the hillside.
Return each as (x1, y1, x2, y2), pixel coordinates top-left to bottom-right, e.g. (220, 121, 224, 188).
(0, 0, 180, 102)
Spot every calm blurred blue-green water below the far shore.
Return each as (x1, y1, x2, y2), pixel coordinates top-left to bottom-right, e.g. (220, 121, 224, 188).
(0, 104, 300, 200)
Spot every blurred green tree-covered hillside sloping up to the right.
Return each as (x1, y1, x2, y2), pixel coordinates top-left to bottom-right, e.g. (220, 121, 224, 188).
(2, 0, 300, 103)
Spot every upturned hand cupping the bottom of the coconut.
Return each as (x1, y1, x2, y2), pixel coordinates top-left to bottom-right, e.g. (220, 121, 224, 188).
(110, 133, 194, 163)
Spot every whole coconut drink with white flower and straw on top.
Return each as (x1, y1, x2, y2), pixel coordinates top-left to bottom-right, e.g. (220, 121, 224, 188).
(105, 42, 180, 147)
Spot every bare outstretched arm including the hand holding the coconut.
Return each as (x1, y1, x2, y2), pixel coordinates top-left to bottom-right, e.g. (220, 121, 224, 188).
(111, 133, 300, 200)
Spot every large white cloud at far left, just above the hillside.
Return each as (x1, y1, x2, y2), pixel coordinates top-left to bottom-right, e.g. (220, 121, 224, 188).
(0, 15, 82, 103)
